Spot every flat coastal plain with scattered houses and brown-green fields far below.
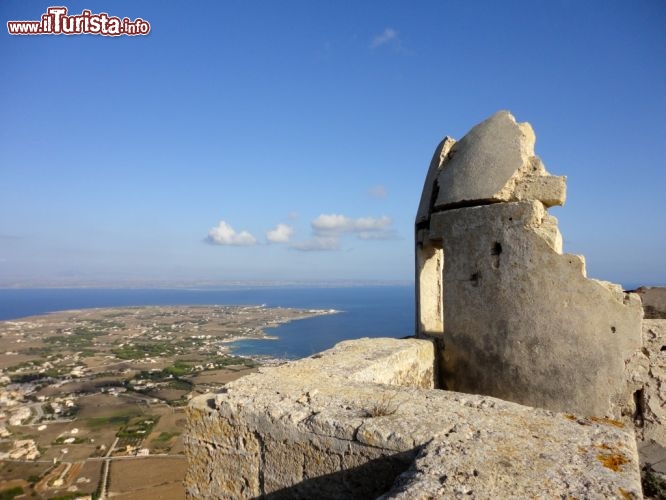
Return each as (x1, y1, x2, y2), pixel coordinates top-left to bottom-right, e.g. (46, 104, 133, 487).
(0, 305, 336, 499)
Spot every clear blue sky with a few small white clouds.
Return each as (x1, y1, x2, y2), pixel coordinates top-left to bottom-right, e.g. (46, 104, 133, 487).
(0, 0, 666, 286)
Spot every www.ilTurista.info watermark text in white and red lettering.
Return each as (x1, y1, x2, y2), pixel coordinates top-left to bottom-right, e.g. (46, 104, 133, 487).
(7, 7, 150, 36)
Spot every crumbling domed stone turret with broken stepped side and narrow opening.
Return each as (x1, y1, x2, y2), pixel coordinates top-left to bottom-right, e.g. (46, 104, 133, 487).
(416, 111, 643, 417)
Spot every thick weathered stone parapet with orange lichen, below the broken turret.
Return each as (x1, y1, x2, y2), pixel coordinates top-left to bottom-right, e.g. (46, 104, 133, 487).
(185, 339, 641, 498)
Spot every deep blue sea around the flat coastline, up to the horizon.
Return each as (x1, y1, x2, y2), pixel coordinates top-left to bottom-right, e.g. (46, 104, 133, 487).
(0, 285, 414, 359)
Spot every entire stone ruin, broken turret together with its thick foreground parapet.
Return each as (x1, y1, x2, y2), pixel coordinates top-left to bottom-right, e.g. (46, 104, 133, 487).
(185, 112, 666, 499)
